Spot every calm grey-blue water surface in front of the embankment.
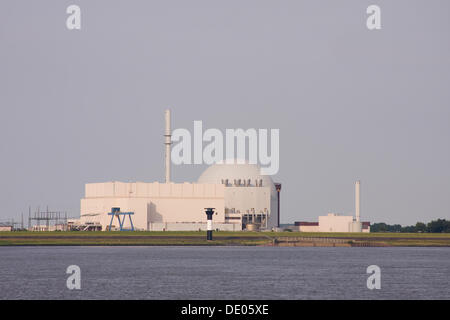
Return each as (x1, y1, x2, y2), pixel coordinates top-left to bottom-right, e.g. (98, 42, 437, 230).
(0, 247, 450, 299)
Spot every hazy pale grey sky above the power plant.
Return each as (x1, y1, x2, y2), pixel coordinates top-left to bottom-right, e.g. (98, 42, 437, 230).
(0, 0, 450, 224)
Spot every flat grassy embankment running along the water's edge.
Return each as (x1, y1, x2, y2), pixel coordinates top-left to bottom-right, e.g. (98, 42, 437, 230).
(0, 231, 450, 247)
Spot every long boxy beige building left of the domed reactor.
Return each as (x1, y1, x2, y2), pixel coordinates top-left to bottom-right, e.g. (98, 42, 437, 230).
(80, 182, 229, 231)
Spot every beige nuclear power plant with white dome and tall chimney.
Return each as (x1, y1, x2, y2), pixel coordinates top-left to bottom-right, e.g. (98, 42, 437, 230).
(68, 110, 281, 231)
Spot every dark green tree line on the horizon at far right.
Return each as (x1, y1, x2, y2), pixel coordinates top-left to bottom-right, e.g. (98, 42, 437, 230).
(370, 219, 450, 233)
